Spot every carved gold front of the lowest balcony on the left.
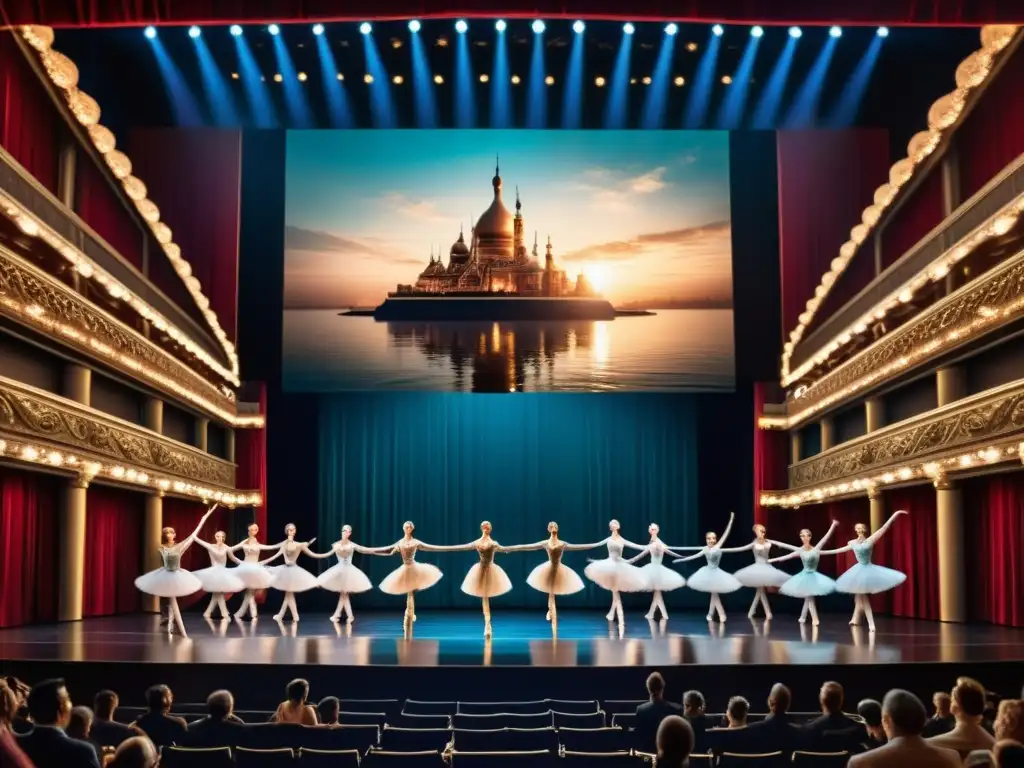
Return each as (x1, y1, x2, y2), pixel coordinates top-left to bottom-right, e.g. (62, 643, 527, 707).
(0, 377, 236, 488)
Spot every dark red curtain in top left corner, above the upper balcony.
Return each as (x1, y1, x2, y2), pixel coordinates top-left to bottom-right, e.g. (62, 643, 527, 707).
(0, 33, 59, 194)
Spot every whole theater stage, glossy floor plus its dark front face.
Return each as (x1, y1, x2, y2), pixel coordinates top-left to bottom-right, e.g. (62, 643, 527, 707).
(0, 610, 1024, 710)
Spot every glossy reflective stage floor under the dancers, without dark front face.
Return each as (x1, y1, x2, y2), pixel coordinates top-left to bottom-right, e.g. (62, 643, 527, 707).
(0, 610, 1024, 668)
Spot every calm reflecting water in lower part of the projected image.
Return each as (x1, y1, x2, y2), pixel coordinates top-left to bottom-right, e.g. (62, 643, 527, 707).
(284, 309, 735, 392)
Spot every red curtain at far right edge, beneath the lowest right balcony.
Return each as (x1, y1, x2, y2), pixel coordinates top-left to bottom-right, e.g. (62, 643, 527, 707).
(964, 472, 1024, 627)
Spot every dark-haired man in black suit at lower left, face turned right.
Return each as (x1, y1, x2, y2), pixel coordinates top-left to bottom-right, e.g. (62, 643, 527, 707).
(17, 680, 99, 768)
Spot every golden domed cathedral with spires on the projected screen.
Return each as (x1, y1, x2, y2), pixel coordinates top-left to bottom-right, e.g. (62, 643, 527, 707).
(390, 163, 597, 298)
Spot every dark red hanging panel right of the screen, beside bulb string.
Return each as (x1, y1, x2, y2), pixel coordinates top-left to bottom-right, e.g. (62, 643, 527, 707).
(778, 129, 889, 334)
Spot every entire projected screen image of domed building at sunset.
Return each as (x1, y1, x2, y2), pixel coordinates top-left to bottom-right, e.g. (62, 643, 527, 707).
(284, 130, 734, 392)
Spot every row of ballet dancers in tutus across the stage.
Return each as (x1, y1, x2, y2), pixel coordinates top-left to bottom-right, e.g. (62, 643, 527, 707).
(135, 507, 906, 637)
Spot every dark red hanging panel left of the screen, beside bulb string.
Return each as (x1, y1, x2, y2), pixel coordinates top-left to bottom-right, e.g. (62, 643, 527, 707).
(127, 128, 242, 339)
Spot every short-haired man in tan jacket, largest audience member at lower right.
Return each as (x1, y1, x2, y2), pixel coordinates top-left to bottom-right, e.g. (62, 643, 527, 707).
(847, 689, 961, 768)
